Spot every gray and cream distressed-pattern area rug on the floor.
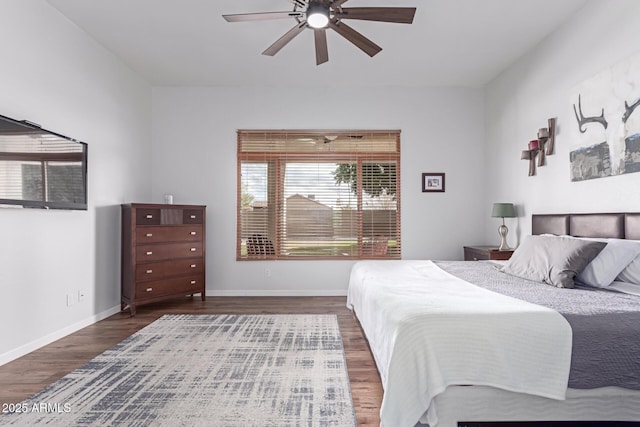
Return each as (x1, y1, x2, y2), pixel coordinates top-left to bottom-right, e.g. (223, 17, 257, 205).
(0, 315, 356, 427)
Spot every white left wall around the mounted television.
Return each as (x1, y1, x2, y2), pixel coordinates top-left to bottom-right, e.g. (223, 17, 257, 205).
(0, 0, 151, 364)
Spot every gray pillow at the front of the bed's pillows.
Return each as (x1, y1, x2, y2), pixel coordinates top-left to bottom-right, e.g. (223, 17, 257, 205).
(502, 236, 607, 288)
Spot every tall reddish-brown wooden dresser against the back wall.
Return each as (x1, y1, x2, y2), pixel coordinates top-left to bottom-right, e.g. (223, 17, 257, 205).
(120, 203, 206, 316)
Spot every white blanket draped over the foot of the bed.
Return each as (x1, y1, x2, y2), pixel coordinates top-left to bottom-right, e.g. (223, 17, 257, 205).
(347, 261, 571, 427)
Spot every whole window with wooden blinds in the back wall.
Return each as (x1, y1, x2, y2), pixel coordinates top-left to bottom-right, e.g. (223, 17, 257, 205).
(236, 130, 401, 260)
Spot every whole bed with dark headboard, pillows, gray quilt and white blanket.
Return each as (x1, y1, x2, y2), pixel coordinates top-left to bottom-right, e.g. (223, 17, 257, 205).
(347, 213, 640, 427)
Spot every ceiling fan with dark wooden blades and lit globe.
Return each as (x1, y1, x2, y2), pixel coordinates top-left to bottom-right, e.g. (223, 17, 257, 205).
(222, 0, 416, 65)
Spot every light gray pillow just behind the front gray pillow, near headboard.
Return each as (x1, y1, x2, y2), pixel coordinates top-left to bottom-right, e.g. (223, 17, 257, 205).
(575, 239, 640, 288)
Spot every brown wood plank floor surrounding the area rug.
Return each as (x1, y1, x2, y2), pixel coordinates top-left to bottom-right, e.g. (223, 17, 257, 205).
(0, 297, 382, 426)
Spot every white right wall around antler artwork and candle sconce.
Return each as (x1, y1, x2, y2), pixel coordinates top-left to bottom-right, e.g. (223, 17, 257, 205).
(485, 0, 640, 245)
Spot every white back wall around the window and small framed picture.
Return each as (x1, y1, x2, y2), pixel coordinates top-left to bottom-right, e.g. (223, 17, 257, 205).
(152, 87, 485, 295)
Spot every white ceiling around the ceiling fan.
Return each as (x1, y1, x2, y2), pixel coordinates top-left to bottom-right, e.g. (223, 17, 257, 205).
(48, 0, 587, 87)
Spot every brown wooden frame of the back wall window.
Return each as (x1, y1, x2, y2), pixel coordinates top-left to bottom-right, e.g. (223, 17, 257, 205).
(236, 130, 401, 261)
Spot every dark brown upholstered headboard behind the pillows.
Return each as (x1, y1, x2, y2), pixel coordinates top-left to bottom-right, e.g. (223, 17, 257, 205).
(531, 213, 640, 240)
